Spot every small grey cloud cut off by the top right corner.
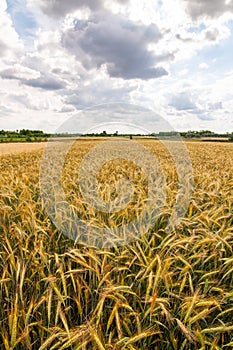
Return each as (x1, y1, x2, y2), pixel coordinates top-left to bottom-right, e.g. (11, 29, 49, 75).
(185, 0, 233, 19)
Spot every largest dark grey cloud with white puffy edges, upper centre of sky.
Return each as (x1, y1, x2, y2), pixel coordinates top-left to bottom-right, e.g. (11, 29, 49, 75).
(62, 11, 170, 80)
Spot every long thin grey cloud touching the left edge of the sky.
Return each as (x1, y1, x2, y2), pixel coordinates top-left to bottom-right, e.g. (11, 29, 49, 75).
(0, 68, 66, 90)
